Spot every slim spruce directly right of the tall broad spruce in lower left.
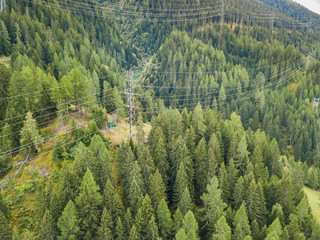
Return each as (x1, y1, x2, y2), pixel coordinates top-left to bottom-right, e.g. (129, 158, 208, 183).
(103, 179, 124, 225)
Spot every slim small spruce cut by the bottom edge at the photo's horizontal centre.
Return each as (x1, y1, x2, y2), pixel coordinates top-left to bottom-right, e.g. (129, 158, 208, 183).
(157, 199, 173, 239)
